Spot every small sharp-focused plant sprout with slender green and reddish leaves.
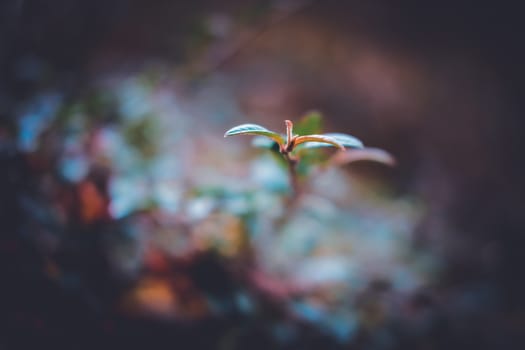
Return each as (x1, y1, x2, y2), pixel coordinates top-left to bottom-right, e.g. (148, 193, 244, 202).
(224, 117, 395, 196)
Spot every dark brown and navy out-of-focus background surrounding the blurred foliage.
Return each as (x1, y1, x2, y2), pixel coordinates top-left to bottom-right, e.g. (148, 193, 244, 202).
(0, 0, 525, 349)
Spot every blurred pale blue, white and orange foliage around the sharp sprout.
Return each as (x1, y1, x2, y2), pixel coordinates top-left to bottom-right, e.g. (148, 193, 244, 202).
(2, 68, 439, 346)
